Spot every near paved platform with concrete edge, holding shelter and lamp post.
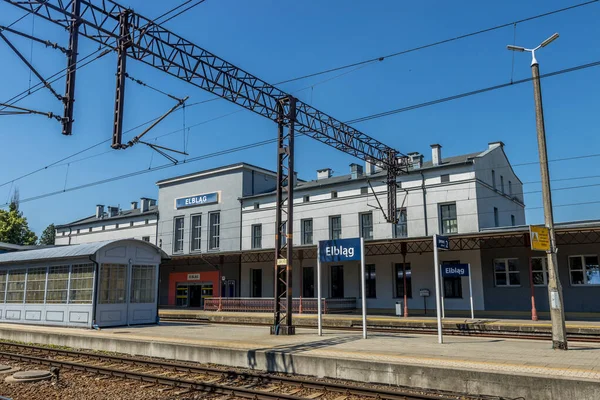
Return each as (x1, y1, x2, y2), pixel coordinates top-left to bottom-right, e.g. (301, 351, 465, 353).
(0, 322, 600, 400)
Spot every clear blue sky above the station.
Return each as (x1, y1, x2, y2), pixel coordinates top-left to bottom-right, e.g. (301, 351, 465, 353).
(0, 0, 600, 235)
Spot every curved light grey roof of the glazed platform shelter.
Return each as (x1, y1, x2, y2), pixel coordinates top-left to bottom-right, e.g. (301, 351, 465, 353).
(0, 239, 168, 265)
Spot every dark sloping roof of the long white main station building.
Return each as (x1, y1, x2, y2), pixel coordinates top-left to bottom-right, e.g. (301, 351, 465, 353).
(242, 152, 482, 199)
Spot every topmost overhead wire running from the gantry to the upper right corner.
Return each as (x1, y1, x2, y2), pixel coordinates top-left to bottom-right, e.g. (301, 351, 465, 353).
(279, 0, 600, 84)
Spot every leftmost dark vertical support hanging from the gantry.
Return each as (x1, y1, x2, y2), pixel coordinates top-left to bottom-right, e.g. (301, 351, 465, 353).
(62, 0, 81, 135)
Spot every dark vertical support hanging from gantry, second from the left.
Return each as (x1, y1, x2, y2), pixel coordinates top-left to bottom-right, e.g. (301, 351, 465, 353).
(111, 10, 131, 149)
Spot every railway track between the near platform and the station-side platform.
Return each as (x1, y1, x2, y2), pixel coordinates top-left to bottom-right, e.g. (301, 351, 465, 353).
(160, 318, 600, 343)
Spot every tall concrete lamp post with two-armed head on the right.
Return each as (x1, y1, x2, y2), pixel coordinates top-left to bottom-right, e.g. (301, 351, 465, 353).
(507, 33, 568, 350)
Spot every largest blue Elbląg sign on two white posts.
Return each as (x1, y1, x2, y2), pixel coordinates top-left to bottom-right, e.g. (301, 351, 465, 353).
(317, 238, 367, 339)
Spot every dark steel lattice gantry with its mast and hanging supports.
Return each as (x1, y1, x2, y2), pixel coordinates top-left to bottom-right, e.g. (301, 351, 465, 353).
(4, 0, 408, 334)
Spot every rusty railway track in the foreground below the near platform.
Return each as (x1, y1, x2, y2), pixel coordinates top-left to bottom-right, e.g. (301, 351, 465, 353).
(0, 342, 499, 400)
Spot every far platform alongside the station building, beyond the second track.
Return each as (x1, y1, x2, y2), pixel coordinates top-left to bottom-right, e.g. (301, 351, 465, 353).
(159, 309, 600, 338)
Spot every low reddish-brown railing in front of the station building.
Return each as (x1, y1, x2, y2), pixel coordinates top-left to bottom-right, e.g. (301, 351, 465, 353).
(204, 297, 356, 314)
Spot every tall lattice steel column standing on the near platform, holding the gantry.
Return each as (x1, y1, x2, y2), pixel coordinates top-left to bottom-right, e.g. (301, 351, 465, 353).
(271, 97, 296, 335)
